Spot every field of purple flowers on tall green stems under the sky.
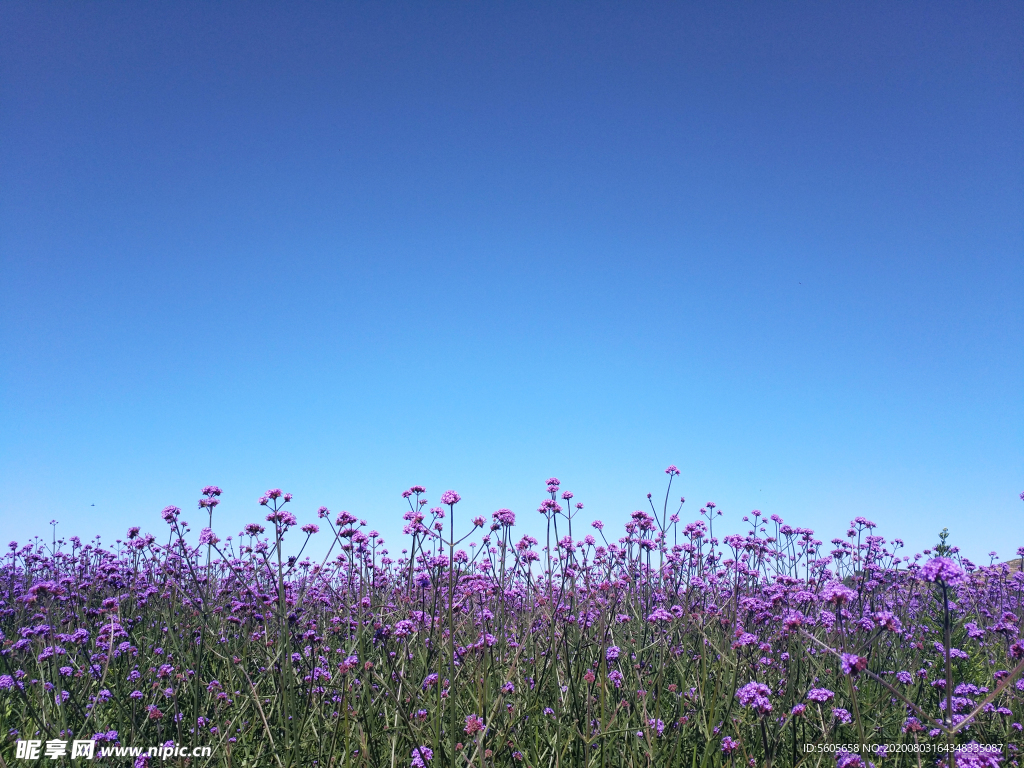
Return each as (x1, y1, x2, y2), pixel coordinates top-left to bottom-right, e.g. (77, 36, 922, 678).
(0, 479, 1024, 768)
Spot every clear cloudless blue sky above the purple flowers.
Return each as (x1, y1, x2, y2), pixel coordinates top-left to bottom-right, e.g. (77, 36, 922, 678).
(0, 2, 1024, 559)
